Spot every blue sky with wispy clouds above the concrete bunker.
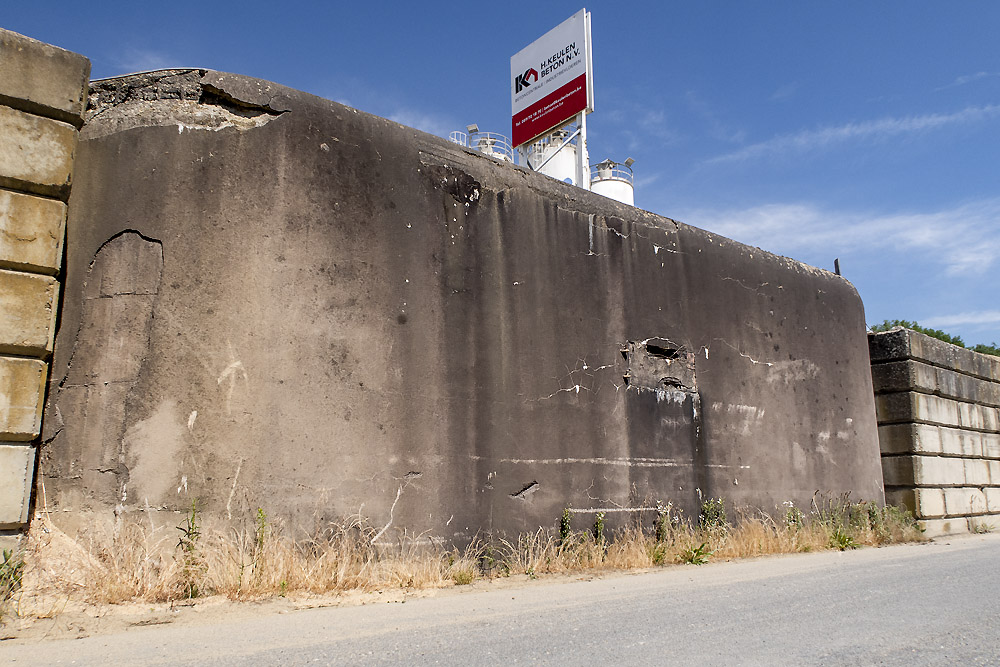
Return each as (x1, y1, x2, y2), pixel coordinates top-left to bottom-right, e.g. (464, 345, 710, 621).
(9, 0, 1000, 344)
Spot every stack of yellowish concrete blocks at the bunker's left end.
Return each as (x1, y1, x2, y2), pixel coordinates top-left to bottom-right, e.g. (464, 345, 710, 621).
(0, 29, 90, 530)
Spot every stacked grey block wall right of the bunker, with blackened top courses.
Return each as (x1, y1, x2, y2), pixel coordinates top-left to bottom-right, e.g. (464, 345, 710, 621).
(868, 329, 1000, 535)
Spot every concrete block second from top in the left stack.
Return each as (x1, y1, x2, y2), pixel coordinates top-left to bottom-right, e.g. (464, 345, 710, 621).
(0, 107, 77, 196)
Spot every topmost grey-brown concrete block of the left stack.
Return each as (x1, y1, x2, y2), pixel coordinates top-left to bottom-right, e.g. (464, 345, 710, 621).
(0, 30, 90, 120)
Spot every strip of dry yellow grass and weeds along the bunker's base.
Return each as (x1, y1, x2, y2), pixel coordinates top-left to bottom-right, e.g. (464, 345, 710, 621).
(5, 498, 923, 615)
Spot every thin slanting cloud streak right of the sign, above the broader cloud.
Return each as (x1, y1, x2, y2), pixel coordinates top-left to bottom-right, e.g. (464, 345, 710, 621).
(705, 104, 1000, 164)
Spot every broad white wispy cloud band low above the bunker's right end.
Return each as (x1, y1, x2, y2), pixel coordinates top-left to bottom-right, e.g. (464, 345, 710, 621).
(678, 198, 1000, 275)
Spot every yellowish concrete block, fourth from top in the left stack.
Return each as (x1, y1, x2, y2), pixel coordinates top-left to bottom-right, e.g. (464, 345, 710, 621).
(0, 270, 59, 356)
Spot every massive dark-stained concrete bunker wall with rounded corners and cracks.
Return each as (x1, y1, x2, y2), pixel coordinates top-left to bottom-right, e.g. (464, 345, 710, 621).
(41, 70, 882, 540)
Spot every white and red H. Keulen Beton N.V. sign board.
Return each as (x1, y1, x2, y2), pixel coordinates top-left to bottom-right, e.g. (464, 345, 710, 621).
(510, 9, 594, 146)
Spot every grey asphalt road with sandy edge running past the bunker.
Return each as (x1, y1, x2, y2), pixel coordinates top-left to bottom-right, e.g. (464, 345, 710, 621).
(0, 535, 1000, 667)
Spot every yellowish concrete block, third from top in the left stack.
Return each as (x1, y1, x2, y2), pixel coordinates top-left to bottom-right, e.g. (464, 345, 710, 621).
(0, 190, 66, 275)
